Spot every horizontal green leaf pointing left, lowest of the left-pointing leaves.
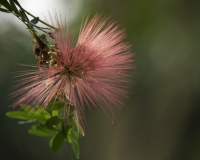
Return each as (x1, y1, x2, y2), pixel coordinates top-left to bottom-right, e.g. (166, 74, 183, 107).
(28, 125, 58, 137)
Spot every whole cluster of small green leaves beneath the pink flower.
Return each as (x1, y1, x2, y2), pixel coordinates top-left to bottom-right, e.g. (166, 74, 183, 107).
(6, 103, 84, 159)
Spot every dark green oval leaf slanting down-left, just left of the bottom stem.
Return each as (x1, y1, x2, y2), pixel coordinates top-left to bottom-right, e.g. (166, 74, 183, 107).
(51, 129, 65, 153)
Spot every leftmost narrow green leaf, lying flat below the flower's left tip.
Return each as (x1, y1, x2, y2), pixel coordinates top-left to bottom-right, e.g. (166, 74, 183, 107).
(6, 111, 35, 120)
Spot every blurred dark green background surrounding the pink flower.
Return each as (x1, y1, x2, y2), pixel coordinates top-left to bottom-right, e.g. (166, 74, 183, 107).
(0, 0, 200, 160)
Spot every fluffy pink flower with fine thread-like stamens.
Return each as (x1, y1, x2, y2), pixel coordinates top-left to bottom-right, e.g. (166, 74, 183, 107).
(9, 15, 134, 124)
